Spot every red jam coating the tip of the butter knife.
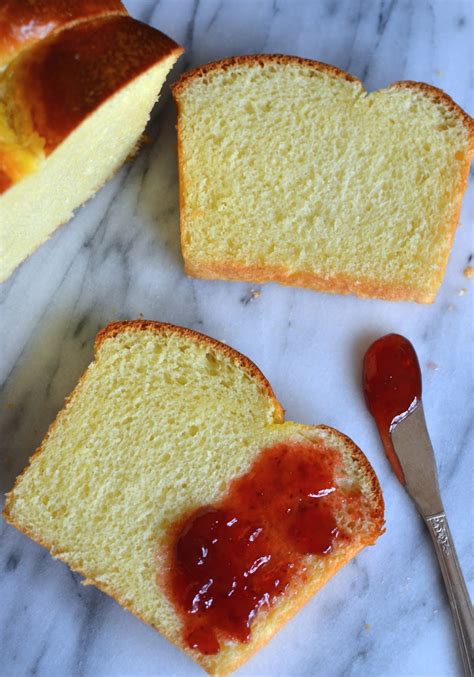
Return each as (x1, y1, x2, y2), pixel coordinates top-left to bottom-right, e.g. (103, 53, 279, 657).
(363, 334, 421, 484)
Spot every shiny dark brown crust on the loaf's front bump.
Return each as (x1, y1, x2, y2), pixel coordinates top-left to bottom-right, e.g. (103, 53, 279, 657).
(7, 15, 183, 154)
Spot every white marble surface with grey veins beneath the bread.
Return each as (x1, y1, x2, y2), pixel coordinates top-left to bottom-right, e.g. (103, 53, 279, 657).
(0, 0, 474, 677)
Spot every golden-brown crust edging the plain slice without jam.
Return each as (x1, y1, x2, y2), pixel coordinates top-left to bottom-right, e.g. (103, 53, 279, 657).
(172, 54, 474, 303)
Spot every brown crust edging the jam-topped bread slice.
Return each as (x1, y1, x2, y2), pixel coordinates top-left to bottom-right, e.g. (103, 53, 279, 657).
(3, 320, 384, 675)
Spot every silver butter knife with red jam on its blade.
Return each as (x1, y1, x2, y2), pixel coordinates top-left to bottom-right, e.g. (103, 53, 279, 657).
(363, 334, 474, 677)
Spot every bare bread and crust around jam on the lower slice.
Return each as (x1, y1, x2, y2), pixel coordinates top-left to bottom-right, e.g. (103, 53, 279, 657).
(4, 321, 383, 675)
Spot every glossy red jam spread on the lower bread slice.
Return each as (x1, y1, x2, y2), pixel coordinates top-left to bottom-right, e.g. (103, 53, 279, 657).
(165, 442, 363, 655)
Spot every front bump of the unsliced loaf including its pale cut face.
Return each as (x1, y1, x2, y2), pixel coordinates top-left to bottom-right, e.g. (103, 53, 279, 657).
(0, 15, 182, 281)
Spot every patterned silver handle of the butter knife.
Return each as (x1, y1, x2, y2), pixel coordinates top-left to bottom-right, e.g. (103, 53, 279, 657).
(425, 512, 474, 677)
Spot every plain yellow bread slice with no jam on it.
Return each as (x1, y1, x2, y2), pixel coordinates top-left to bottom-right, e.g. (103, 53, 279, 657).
(173, 55, 474, 303)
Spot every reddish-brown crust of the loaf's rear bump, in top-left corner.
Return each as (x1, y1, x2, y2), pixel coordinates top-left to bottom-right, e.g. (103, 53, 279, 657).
(0, 0, 127, 66)
